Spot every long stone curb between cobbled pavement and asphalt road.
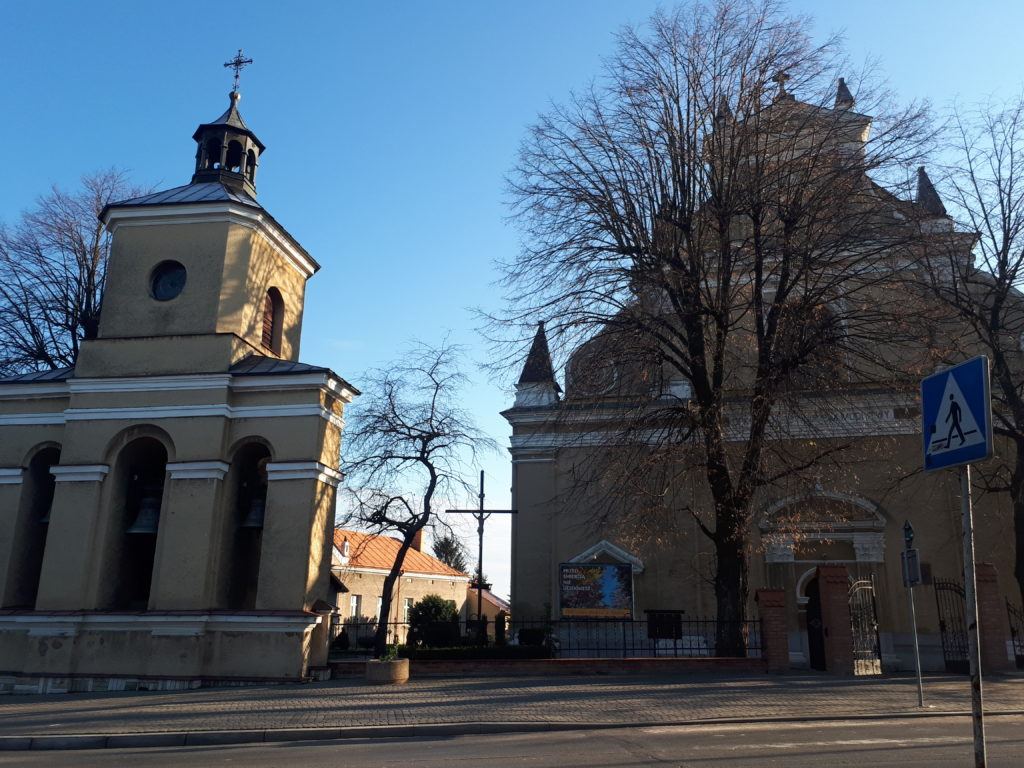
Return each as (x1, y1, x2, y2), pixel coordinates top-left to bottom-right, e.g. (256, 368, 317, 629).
(0, 710, 1024, 752)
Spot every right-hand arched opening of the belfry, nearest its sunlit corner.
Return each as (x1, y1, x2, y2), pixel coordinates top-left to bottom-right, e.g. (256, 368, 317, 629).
(226, 442, 270, 610)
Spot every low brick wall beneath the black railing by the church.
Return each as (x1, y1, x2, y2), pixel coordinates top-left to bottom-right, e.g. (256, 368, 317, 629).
(331, 656, 765, 680)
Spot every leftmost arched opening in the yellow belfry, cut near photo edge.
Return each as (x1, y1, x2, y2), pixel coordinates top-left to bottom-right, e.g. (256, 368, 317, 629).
(5, 445, 60, 608)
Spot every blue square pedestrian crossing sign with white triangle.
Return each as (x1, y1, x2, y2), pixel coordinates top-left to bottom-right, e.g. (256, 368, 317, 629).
(921, 355, 992, 472)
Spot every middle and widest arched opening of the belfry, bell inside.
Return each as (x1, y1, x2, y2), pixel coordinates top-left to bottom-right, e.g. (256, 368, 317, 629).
(110, 437, 167, 610)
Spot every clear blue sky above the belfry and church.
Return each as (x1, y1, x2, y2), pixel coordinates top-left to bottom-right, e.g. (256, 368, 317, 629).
(0, 0, 1024, 594)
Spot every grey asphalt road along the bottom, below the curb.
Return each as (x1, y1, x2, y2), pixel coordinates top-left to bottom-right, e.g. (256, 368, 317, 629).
(0, 716, 1024, 768)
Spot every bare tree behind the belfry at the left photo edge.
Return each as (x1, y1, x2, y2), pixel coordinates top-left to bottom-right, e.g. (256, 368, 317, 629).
(0, 169, 143, 375)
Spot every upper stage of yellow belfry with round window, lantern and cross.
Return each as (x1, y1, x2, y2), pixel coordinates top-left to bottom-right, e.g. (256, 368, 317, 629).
(77, 50, 319, 377)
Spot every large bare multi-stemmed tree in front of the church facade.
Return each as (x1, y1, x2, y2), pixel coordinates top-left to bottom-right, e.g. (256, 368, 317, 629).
(495, 0, 929, 650)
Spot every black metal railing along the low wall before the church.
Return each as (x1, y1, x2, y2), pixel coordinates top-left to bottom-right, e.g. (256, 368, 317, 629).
(331, 612, 762, 658)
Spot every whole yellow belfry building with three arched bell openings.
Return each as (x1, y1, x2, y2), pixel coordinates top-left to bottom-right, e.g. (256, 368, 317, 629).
(0, 89, 357, 691)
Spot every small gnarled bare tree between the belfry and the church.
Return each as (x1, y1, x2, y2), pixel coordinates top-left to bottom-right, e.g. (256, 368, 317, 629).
(344, 343, 494, 656)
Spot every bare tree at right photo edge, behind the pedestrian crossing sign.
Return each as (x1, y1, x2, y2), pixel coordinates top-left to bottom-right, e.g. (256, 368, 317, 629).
(922, 96, 1024, 595)
